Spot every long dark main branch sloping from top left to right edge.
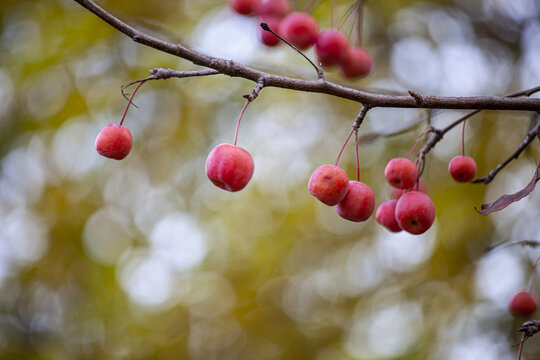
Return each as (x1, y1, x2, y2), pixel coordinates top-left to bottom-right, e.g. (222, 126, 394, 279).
(74, 0, 540, 112)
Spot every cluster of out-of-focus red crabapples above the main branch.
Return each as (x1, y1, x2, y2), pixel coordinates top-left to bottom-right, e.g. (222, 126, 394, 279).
(229, 0, 373, 79)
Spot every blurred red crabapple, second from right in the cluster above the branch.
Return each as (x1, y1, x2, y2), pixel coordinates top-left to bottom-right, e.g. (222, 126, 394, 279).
(315, 29, 349, 66)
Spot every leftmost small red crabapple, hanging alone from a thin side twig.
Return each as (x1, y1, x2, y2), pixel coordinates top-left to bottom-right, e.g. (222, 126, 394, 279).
(96, 124, 133, 160)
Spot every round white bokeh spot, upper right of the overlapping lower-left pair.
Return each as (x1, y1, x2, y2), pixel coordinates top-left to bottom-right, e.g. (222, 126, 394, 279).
(150, 212, 208, 271)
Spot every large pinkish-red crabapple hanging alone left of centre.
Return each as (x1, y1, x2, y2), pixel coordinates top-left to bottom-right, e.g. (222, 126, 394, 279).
(206, 144, 255, 192)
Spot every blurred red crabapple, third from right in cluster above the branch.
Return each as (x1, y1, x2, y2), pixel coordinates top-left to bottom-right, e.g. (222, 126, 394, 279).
(279, 12, 319, 50)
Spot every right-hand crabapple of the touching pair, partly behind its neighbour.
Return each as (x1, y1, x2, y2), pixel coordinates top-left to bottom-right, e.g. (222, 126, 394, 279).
(336, 180, 375, 222)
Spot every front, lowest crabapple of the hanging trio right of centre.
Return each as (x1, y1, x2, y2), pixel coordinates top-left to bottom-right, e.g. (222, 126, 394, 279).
(396, 191, 435, 235)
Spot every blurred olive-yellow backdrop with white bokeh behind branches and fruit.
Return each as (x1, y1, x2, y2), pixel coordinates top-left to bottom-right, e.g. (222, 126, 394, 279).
(0, 0, 540, 360)
